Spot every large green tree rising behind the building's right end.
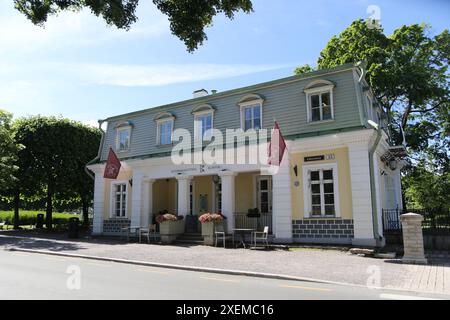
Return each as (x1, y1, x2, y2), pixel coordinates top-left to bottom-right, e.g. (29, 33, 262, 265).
(295, 20, 450, 210)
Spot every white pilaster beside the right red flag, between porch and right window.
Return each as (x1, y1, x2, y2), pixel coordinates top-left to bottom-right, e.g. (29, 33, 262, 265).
(272, 151, 292, 242)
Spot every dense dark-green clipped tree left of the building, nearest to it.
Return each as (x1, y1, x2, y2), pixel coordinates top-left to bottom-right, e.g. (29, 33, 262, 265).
(14, 116, 100, 229)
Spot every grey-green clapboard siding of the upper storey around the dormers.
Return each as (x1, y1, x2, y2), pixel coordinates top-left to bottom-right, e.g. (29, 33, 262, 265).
(101, 69, 361, 160)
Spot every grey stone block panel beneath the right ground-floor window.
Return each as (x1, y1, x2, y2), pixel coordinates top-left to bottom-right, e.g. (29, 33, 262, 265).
(292, 218, 354, 243)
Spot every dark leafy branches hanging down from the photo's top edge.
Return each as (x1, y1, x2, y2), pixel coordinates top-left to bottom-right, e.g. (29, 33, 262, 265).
(14, 0, 253, 52)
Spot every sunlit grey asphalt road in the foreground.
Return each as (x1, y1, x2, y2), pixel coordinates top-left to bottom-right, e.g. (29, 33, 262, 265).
(0, 250, 450, 300)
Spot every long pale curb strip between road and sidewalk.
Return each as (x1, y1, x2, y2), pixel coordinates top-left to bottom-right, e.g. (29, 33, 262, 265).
(5, 248, 448, 295)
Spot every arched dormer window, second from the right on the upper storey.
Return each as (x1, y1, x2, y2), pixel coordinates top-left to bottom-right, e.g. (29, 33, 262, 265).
(238, 94, 264, 131)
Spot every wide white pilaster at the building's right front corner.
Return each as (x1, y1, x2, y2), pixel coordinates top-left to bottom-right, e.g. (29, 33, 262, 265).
(348, 143, 376, 246)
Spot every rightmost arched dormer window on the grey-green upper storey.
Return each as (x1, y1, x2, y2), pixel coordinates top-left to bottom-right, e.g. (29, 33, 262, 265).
(304, 80, 334, 123)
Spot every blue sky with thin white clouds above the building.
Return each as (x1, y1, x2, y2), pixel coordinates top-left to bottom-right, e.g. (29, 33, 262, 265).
(0, 0, 450, 123)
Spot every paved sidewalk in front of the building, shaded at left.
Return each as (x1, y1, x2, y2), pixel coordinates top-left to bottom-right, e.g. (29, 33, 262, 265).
(0, 233, 450, 294)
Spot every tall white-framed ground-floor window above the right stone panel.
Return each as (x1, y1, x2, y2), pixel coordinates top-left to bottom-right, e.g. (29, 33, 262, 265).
(303, 163, 340, 218)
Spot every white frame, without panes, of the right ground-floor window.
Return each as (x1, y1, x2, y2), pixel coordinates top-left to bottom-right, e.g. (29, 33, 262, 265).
(303, 163, 341, 219)
